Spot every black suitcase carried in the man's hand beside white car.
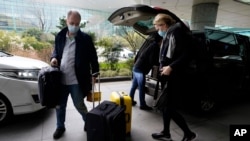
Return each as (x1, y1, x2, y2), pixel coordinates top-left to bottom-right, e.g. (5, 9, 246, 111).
(38, 66, 62, 108)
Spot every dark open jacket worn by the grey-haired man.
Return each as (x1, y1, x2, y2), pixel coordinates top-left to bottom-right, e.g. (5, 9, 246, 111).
(52, 27, 99, 94)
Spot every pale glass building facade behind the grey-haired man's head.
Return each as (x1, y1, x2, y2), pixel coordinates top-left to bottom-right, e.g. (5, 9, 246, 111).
(0, 0, 115, 36)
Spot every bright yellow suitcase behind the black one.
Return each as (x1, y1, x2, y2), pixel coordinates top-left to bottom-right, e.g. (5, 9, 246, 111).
(110, 91, 132, 135)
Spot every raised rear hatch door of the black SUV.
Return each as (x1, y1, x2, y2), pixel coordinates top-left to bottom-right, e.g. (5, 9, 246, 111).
(108, 4, 184, 35)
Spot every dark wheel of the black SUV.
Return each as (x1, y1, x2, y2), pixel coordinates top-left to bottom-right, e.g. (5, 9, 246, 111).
(200, 97, 216, 113)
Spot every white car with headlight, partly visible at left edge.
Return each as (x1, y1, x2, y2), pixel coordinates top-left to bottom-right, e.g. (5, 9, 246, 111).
(0, 51, 49, 124)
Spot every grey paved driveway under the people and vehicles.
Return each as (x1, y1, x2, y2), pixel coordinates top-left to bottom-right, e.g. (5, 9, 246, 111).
(0, 81, 250, 141)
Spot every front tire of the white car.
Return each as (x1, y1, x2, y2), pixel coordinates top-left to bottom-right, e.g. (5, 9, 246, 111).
(0, 94, 13, 125)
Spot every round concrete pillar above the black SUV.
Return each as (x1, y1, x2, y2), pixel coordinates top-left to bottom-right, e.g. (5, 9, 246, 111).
(191, 0, 219, 30)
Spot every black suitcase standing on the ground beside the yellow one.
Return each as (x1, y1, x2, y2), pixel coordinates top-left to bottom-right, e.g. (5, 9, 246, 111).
(85, 101, 126, 141)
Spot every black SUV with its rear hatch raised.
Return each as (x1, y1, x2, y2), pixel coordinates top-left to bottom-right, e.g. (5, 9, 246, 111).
(108, 5, 250, 111)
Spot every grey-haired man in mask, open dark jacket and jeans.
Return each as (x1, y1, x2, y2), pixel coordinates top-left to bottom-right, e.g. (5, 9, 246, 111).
(51, 10, 99, 139)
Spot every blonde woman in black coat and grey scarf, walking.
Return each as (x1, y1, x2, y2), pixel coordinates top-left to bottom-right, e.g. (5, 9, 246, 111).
(152, 14, 197, 141)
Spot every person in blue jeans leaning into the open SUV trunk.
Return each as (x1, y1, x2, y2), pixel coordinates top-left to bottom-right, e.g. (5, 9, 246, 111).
(130, 33, 162, 110)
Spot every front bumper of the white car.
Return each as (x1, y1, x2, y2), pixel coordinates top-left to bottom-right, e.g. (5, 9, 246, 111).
(0, 76, 44, 115)
